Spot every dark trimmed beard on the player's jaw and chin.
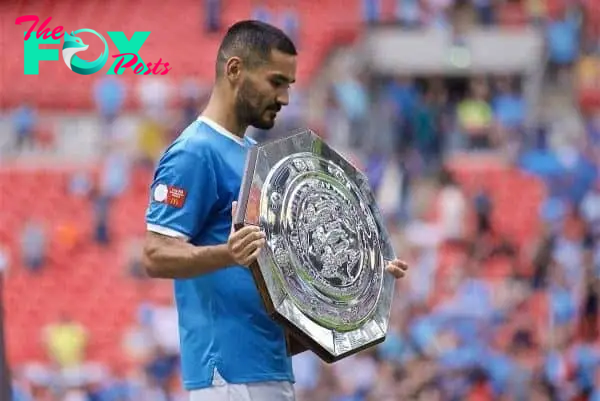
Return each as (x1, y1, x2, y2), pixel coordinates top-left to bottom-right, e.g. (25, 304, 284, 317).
(235, 79, 279, 130)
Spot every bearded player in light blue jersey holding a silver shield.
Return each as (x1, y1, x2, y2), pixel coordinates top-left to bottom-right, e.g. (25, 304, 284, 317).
(144, 21, 406, 401)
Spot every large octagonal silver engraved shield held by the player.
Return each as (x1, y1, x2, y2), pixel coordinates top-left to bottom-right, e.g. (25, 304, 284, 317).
(234, 130, 394, 363)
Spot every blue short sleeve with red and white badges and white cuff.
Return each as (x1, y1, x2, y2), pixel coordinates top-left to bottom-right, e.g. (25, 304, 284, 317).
(146, 149, 217, 240)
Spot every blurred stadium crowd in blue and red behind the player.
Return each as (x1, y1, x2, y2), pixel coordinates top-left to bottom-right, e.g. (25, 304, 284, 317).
(7, 0, 600, 401)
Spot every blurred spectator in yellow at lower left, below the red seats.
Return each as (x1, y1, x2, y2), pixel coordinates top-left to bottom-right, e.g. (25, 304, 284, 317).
(44, 314, 88, 369)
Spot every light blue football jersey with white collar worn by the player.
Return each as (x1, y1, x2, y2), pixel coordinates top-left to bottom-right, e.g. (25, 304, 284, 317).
(146, 117, 294, 390)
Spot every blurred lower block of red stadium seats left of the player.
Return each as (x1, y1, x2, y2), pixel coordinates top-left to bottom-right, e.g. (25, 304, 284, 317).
(0, 165, 170, 363)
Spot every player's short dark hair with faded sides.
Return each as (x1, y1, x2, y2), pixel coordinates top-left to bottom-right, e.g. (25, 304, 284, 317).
(216, 20, 297, 77)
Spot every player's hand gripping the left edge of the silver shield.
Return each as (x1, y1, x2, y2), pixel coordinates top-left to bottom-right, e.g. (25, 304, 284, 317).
(227, 202, 266, 266)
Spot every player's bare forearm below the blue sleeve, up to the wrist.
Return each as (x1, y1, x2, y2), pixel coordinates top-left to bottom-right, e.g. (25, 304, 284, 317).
(144, 240, 235, 278)
